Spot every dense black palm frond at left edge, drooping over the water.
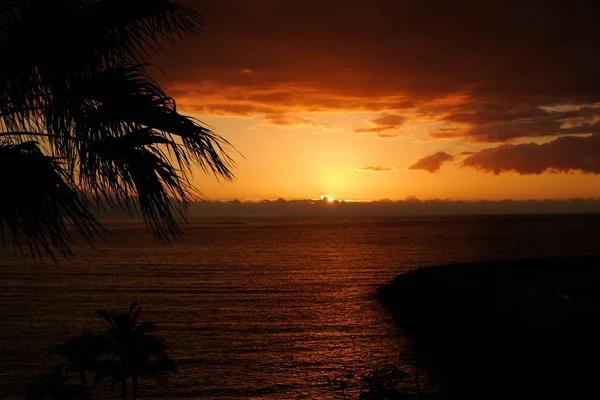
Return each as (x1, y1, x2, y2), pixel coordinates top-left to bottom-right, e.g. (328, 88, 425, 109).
(0, 141, 101, 258)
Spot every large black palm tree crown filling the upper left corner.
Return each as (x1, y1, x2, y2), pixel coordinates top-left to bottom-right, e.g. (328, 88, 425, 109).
(0, 0, 234, 258)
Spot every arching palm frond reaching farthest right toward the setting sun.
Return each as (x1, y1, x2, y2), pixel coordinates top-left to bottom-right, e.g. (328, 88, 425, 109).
(78, 65, 234, 180)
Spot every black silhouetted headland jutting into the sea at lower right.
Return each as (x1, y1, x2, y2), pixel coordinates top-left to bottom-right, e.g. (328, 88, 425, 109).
(380, 256, 600, 399)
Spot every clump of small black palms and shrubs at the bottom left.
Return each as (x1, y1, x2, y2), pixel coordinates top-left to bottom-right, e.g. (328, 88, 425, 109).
(27, 303, 176, 400)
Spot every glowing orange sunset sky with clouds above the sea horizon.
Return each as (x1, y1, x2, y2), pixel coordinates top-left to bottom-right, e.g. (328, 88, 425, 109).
(155, 0, 600, 200)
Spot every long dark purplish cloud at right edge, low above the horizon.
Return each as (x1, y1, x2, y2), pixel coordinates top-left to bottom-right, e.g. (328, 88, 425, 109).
(463, 135, 600, 174)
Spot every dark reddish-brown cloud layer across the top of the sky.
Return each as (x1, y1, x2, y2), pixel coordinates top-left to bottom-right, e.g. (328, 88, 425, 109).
(159, 0, 600, 102)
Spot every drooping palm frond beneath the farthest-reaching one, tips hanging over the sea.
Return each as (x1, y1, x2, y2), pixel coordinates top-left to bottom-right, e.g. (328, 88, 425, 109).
(81, 129, 194, 241)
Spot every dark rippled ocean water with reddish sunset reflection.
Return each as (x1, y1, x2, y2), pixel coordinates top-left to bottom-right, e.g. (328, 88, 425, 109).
(0, 215, 600, 399)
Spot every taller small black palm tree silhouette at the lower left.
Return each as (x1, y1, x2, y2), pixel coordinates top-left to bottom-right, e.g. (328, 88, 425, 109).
(97, 302, 176, 400)
